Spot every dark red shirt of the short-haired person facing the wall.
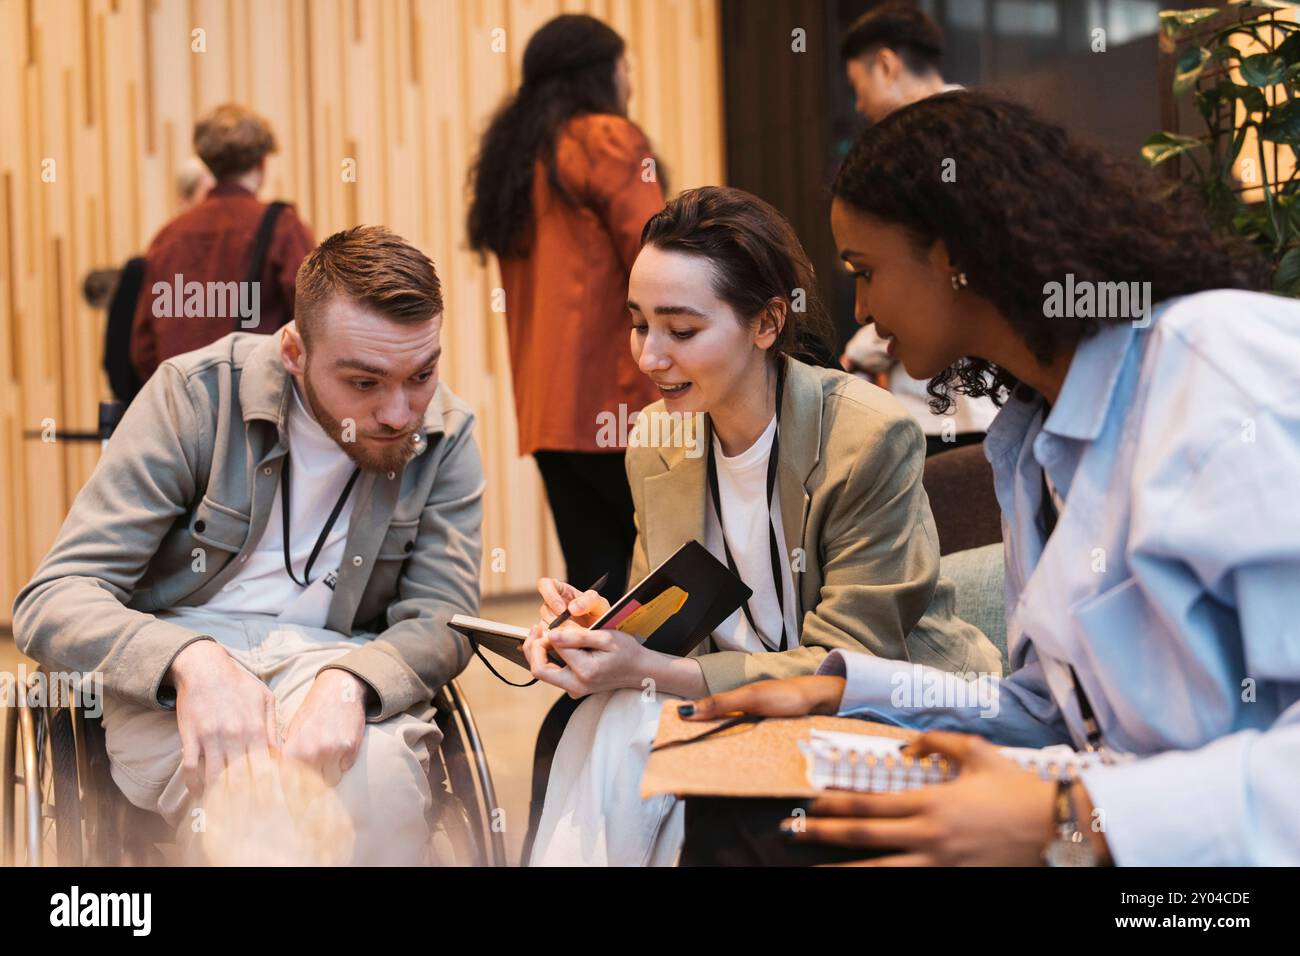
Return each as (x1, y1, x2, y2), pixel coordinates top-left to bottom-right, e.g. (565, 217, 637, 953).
(131, 182, 316, 381)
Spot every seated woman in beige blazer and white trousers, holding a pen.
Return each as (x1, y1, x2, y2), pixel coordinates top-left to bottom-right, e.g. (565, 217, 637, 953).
(525, 187, 1000, 865)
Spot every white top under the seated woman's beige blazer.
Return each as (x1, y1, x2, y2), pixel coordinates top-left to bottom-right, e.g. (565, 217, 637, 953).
(705, 416, 800, 653)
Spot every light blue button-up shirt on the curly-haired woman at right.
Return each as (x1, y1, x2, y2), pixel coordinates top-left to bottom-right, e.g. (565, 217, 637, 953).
(819, 290, 1300, 865)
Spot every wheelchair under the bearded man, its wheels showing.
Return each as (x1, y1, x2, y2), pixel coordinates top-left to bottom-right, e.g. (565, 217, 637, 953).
(0, 671, 506, 866)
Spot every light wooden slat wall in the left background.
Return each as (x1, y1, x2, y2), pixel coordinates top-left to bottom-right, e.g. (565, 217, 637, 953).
(0, 0, 723, 623)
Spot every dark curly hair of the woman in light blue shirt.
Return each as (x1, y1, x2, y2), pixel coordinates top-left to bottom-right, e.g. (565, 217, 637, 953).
(831, 91, 1268, 412)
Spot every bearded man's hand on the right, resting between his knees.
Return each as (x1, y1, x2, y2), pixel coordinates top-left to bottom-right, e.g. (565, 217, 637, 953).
(283, 667, 368, 787)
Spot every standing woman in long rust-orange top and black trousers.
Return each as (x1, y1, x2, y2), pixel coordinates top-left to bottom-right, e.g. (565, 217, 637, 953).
(468, 14, 663, 600)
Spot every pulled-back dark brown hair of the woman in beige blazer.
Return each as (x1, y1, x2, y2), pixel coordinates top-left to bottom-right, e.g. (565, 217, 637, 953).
(641, 186, 836, 365)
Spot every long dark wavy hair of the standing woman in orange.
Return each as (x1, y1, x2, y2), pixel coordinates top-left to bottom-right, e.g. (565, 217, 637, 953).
(468, 14, 625, 256)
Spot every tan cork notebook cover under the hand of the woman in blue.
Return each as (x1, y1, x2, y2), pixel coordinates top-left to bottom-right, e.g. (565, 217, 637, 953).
(641, 700, 915, 799)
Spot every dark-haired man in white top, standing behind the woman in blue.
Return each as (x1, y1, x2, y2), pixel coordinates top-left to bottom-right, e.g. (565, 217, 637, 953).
(840, 3, 997, 455)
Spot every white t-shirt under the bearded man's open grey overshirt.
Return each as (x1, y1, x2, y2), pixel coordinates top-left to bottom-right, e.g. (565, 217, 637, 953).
(195, 384, 356, 627)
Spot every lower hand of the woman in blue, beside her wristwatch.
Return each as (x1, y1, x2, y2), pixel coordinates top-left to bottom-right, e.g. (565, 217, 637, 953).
(781, 731, 1056, 866)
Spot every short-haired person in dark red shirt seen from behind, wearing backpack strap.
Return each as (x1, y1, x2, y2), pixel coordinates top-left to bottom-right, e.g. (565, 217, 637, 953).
(131, 103, 316, 381)
